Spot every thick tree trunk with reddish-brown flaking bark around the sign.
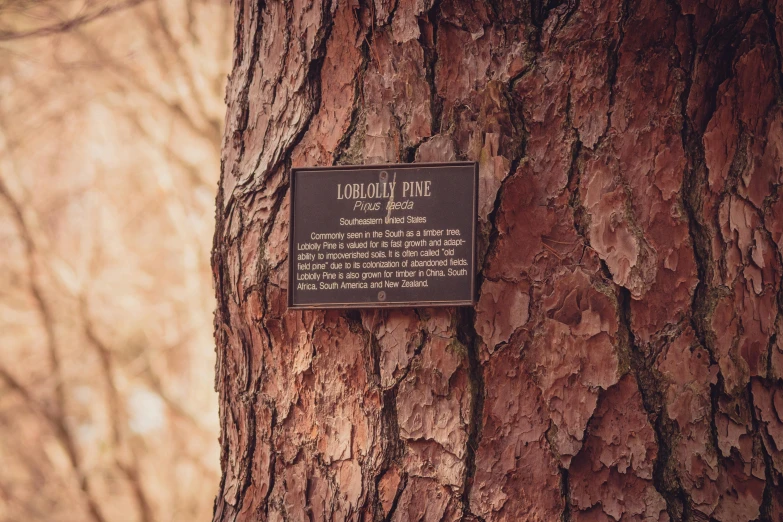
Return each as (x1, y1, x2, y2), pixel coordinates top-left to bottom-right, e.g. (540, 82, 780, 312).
(212, 0, 783, 522)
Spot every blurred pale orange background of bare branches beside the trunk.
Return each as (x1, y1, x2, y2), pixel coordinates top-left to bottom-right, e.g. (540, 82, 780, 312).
(0, 0, 233, 522)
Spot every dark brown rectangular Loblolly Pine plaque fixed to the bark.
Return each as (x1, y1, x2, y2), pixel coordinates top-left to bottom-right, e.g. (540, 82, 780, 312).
(288, 162, 478, 308)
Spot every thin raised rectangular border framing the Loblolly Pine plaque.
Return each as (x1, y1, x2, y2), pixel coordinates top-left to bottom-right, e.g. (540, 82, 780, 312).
(286, 161, 479, 310)
